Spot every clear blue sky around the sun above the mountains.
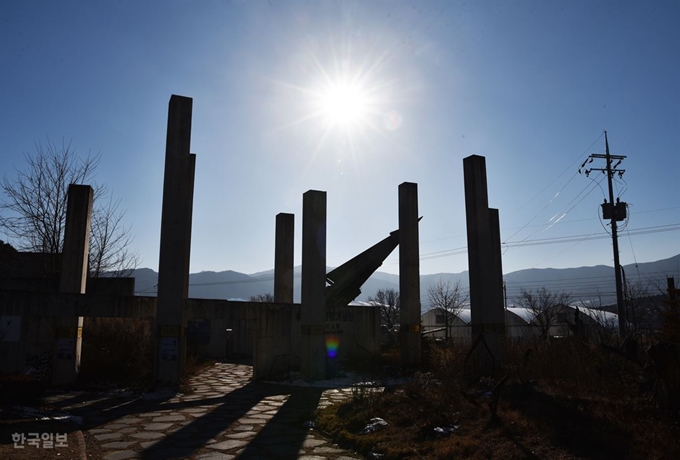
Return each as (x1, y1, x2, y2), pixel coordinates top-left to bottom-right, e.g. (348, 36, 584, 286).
(0, 0, 680, 273)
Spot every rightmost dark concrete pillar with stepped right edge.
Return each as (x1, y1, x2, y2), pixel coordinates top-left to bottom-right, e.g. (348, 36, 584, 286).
(463, 155, 505, 373)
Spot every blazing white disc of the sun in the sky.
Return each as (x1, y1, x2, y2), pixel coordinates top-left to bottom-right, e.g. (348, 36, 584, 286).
(319, 83, 369, 125)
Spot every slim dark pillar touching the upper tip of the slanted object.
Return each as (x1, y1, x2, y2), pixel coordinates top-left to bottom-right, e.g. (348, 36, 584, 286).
(399, 182, 421, 369)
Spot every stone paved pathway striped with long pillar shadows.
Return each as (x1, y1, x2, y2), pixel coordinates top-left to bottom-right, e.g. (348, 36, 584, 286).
(45, 363, 363, 460)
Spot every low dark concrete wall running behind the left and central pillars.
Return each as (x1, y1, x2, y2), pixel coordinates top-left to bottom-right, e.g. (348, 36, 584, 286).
(0, 290, 380, 378)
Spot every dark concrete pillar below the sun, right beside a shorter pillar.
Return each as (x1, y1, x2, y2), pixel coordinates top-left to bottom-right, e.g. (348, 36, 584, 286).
(300, 190, 326, 381)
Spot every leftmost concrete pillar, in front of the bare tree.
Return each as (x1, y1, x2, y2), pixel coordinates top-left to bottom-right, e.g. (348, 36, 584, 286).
(52, 184, 94, 386)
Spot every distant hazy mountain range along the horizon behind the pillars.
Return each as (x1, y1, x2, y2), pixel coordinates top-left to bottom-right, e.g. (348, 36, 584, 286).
(132, 254, 680, 309)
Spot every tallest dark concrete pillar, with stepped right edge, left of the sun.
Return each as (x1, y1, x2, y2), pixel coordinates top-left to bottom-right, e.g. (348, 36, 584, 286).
(155, 95, 196, 387)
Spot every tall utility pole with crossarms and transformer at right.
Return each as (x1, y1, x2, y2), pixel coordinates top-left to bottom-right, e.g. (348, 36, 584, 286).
(579, 131, 627, 338)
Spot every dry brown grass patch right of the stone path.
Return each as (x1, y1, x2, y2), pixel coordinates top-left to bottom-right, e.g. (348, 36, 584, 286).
(317, 338, 680, 460)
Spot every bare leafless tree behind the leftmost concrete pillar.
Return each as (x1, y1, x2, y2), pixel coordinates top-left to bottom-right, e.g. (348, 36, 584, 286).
(0, 139, 138, 276)
